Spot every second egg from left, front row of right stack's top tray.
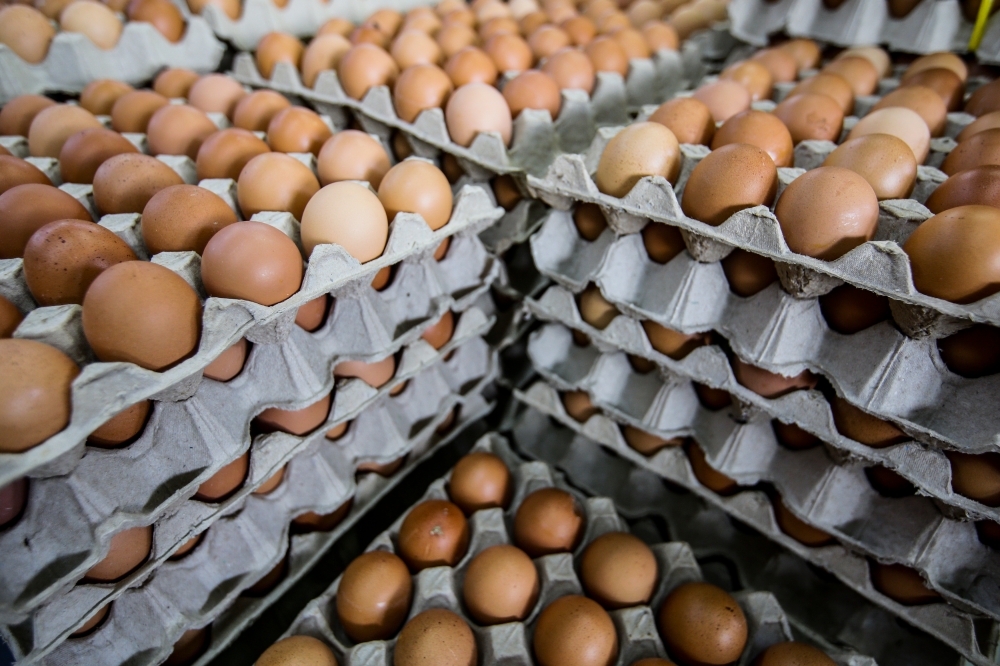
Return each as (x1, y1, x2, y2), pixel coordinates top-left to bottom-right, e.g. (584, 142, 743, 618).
(681, 143, 776, 226)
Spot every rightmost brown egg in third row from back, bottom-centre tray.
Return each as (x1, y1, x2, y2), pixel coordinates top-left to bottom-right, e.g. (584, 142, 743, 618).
(580, 532, 657, 610)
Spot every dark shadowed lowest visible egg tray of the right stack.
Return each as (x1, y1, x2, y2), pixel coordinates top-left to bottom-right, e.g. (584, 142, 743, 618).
(505, 408, 997, 666)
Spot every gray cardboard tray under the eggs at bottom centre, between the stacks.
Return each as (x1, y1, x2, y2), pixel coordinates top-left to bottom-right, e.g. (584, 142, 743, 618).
(285, 433, 874, 666)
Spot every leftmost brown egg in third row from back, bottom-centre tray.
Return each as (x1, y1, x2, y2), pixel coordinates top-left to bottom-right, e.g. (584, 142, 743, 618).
(337, 550, 413, 643)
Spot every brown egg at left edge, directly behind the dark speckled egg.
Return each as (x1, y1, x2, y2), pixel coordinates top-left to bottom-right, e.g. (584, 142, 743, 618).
(0, 183, 92, 259)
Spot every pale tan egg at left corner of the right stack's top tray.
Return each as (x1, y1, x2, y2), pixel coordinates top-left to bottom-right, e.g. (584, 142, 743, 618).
(594, 122, 681, 197)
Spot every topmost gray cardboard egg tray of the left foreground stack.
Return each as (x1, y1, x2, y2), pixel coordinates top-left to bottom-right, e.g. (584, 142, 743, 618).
(0, 150, 503, 485)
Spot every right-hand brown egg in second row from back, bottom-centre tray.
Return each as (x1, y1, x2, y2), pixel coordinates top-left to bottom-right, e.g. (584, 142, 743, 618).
(514, 488, 585, 557)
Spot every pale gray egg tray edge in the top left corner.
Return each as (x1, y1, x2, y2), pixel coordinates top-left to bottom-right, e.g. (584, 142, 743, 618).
(0, 17, 225, 104)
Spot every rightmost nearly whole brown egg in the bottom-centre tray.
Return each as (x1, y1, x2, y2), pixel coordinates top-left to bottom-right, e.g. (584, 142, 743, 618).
(659, 582, 747, 664)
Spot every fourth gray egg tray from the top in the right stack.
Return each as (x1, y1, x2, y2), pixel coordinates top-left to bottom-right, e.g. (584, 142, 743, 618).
(528, 325, 1000, 632)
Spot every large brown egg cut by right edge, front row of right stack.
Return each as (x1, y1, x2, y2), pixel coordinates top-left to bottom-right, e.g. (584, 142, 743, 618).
(904, 205, 1000, 303)
